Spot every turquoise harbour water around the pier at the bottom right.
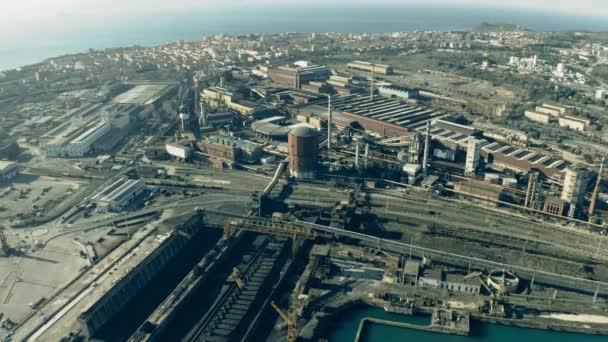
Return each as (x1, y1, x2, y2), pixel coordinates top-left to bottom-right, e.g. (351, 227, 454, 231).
(328, 307, 608, 342)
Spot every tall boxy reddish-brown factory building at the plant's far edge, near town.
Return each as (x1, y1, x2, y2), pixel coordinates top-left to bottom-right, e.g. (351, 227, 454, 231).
(268, 64, 331, 88)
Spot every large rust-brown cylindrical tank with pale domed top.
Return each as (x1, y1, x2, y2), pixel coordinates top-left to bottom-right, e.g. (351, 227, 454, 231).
(287, 126, 319, 179)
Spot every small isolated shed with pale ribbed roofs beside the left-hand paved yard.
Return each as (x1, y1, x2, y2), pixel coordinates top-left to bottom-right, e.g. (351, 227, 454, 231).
(91, 178, 146, 211)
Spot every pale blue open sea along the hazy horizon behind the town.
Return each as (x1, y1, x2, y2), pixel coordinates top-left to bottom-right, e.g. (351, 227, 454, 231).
(0, 2, 608, 70)
